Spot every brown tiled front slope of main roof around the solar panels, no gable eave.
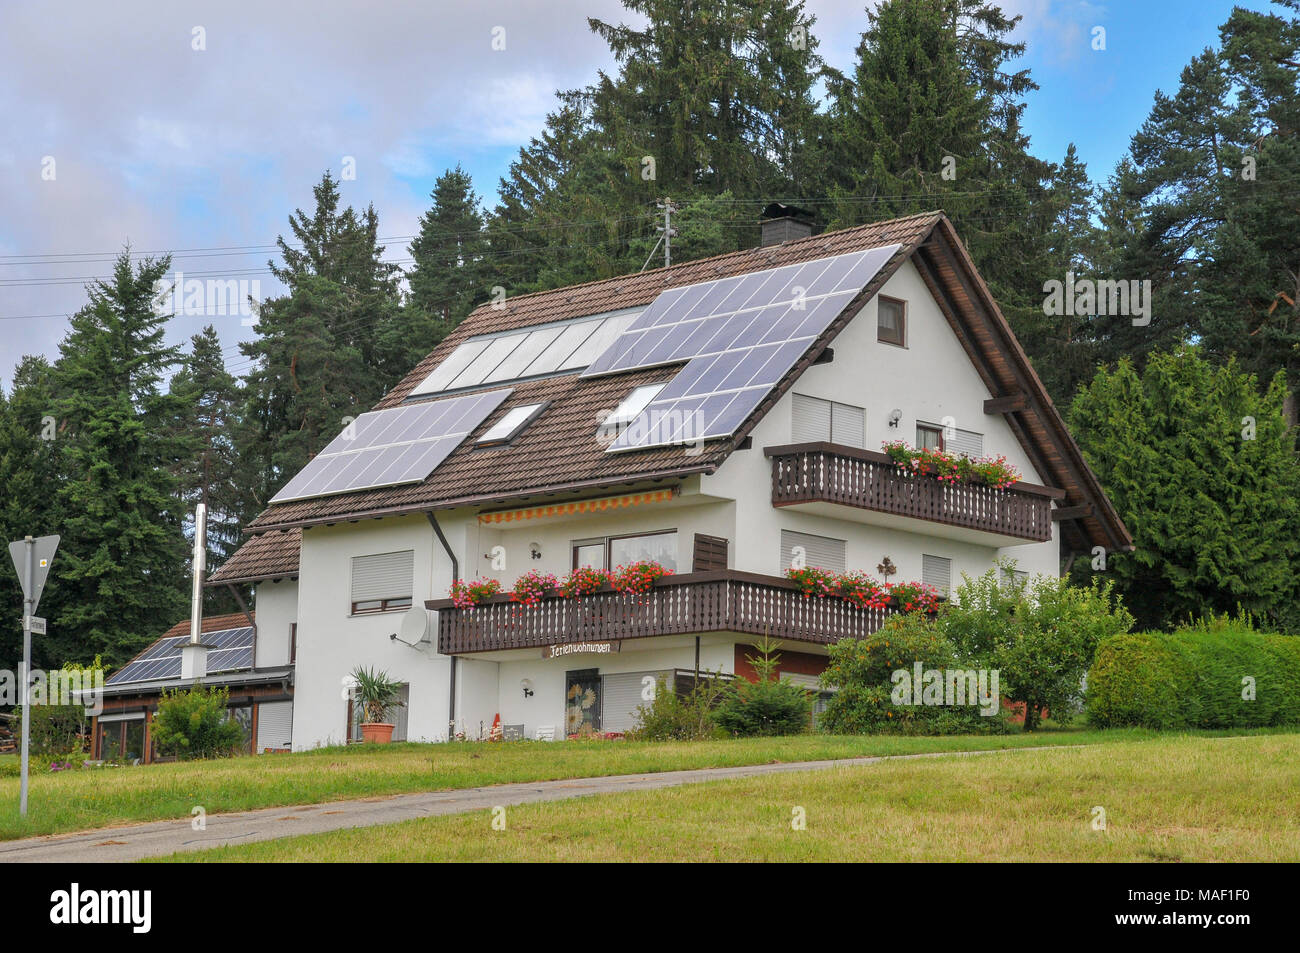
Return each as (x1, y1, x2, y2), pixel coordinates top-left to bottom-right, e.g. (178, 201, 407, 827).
(241, 212, 943, 532)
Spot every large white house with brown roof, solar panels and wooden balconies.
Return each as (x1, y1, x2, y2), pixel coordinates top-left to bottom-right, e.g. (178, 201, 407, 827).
(212, 207, 1131, 749)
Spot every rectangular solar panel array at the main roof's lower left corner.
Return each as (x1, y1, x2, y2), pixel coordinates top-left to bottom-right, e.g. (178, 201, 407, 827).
(270, 387, 510, 503)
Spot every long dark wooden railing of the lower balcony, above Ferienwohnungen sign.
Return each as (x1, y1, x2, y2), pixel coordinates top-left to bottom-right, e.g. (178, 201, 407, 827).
(425, 569, 893, 655)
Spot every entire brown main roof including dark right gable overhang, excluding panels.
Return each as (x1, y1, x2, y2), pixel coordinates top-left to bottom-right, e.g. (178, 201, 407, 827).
(233, 212, 1132, 551)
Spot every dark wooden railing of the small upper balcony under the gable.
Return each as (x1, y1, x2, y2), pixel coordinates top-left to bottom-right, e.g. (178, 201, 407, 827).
(764, 443, 1065, 542)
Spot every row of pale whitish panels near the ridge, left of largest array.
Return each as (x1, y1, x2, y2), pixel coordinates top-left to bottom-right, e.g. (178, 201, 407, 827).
(411, 313, 637, 397)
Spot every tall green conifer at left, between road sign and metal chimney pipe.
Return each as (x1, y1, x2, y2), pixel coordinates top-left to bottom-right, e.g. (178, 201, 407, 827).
(42, 252, 189, 664)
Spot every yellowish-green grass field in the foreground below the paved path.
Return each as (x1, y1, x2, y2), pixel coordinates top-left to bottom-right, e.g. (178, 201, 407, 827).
(161, 735, 1300, 862)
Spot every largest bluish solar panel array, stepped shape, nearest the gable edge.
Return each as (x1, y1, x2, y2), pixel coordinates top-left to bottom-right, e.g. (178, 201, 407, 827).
(584, 244, 900, 451)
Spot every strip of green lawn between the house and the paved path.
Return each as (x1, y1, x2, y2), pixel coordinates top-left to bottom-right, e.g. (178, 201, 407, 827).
(0, 731, 1170, 840)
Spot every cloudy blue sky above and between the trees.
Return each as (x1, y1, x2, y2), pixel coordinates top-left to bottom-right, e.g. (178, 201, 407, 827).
(0, 0, 1270, 385)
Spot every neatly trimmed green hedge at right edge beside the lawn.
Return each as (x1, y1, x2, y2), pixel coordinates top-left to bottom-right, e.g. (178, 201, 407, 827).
(1087, 627, 1300, 728)
